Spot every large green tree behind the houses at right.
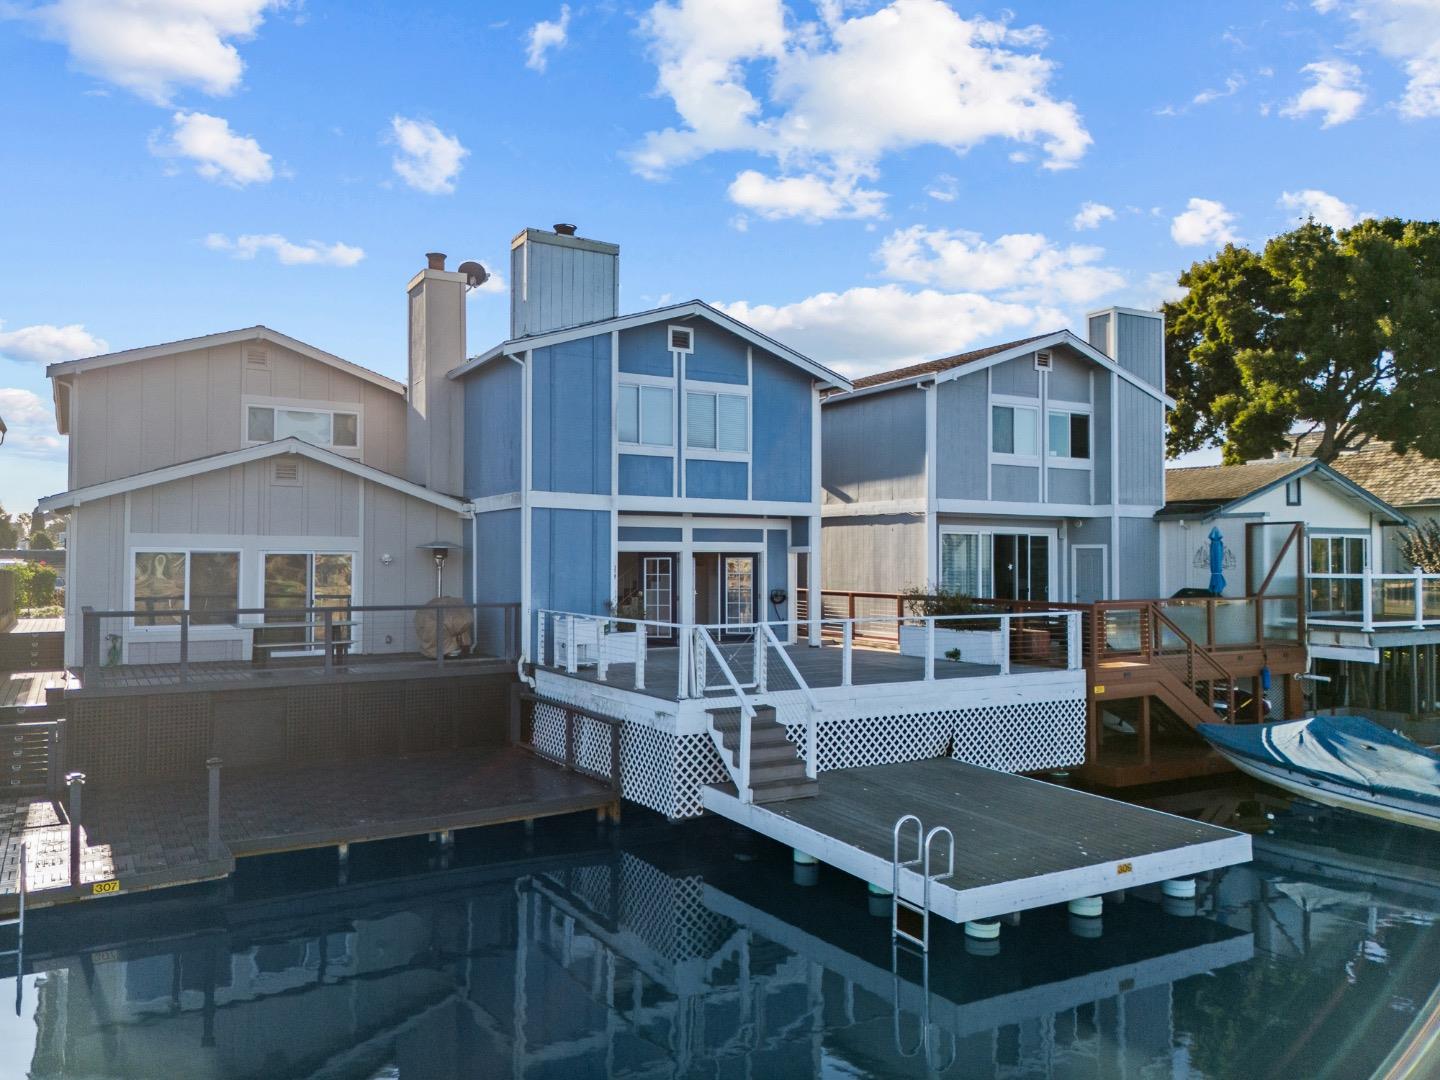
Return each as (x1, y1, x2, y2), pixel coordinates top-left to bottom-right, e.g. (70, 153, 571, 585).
(1165, 217, 1440, 462)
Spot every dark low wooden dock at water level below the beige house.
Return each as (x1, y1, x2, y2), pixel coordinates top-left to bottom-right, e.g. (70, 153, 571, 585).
(0, 747, 615, 914)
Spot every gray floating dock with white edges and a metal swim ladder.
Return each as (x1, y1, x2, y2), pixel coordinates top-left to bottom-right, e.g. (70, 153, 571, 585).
(704, 757, 1250, 922)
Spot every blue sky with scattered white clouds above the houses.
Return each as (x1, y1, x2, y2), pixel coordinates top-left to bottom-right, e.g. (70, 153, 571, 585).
(0, 0, 1440, 510)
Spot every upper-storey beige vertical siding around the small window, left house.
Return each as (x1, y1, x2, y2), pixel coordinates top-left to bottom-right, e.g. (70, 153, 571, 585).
(71, 341, 405, 487)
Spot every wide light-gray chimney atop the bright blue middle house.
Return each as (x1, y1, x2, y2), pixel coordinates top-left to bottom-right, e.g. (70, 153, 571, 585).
(510, 225, 621, 337)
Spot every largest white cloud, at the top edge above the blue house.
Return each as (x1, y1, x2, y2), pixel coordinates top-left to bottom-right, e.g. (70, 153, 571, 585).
(629, 0, 1092, 217)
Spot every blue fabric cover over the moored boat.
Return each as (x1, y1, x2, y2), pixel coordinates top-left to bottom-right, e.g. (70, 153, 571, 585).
(1198, 716, 1440, 806)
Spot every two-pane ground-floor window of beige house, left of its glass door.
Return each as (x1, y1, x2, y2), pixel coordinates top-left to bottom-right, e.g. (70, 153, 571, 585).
(131, 549, 240, 626)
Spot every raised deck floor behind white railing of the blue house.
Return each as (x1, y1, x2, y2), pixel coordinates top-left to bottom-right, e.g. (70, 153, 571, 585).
(552, 644, 1054, 701)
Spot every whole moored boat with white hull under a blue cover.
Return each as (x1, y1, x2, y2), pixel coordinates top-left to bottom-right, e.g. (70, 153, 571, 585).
(1198, 716, 1440, 829)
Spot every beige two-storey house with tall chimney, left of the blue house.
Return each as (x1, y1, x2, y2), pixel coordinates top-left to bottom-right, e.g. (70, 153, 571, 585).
(40, 259, 469, 664)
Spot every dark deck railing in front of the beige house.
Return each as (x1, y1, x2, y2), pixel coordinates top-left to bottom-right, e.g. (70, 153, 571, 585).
(81, 599, 520, 688)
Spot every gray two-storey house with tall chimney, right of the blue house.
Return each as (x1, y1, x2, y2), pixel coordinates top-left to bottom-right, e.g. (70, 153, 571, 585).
(821, 308, 1172, 602)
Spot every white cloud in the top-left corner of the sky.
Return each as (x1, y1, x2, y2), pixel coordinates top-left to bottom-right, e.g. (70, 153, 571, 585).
(18, 0, 285, 105)
